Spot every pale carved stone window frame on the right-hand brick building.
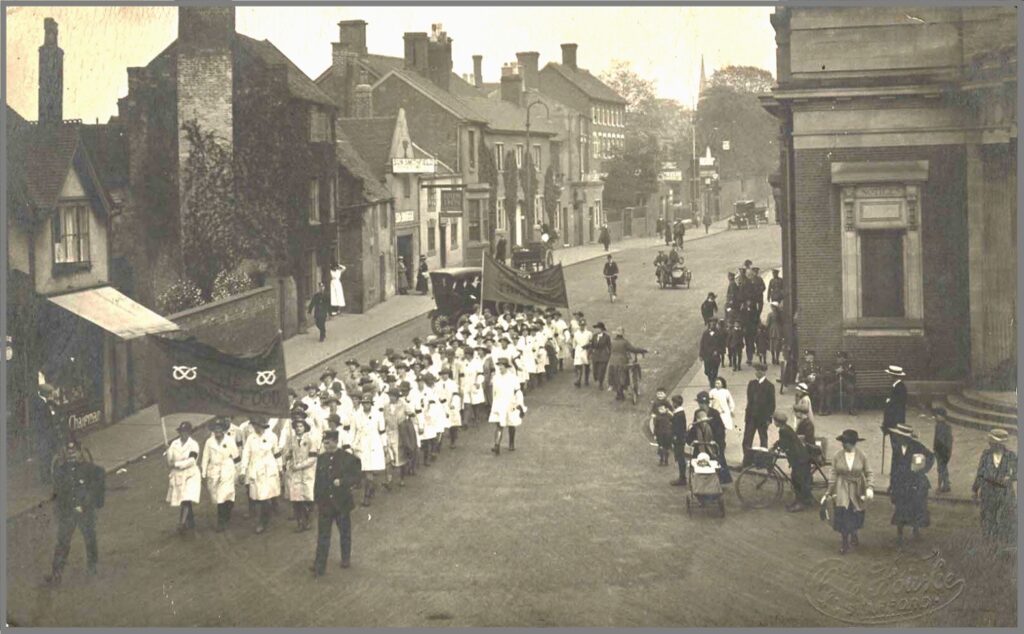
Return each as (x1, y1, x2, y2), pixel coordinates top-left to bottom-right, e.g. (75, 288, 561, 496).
(831, 161, 929, 337)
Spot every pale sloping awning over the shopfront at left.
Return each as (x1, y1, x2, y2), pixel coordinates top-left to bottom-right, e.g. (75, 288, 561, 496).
(47, 286, 179, 339)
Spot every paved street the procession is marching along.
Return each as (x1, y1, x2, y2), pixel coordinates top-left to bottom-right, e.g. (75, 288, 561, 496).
(7, 228, 1016, 627)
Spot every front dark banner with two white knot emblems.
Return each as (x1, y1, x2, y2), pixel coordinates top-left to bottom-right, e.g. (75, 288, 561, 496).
(152, 334, 288, 417)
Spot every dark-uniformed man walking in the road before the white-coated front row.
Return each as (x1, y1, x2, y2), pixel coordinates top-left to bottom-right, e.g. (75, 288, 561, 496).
(312, 431, 362, 578)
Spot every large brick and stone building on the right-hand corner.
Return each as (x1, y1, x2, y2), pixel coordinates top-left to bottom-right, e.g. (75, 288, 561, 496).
(763, 7, 1017, 391)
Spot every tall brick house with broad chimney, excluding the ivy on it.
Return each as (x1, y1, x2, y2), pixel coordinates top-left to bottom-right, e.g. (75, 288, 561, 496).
(115, 7, 341, 336)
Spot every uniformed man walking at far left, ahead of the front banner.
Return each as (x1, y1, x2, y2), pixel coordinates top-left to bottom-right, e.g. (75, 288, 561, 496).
(46, 439, 106, 585)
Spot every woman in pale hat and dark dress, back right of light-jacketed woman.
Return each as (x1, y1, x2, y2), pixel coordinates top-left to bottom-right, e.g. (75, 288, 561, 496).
(889, 423, 935, 546)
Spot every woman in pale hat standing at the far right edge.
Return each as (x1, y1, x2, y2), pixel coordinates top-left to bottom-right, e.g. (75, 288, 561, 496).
(971, 429, 1017, 543)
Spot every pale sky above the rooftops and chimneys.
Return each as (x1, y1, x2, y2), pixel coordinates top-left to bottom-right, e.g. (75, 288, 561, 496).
(5, 6, 775, 123)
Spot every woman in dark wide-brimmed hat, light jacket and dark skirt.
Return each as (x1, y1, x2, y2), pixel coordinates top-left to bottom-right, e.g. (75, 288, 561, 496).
(821, 429, 874, 555)
